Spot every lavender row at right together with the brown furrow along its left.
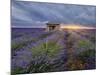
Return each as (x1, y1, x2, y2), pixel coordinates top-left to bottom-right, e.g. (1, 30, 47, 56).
(65, 29, 96, 70)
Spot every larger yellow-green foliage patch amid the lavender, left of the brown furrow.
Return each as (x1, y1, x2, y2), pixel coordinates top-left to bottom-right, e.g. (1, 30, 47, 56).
(31, 41, 61, 57)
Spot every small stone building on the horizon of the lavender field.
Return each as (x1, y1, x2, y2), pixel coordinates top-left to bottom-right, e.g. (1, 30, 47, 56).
(46, 23, 60, 31)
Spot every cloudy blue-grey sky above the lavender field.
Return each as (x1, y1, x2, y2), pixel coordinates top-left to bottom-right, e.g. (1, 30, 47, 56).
(11, 1, 96, 27)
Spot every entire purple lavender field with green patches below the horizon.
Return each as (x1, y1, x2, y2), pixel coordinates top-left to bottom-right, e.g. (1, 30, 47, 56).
(11, 28, 96, 75)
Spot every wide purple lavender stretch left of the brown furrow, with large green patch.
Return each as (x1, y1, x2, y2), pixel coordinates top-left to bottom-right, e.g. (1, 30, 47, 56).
(11, 28, 67, 74)
